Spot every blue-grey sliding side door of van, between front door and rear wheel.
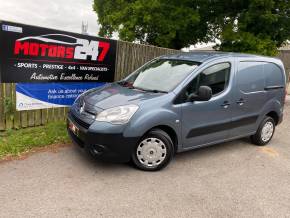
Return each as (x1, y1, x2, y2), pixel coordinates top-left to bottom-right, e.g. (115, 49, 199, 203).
(231, 61, 267, 137)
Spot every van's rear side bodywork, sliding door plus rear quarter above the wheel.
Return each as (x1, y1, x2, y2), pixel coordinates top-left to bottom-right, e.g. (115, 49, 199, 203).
(230, 60, 286, 137)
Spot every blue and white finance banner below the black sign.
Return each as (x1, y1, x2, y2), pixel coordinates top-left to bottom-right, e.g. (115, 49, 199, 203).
(16, 82, 104, 111)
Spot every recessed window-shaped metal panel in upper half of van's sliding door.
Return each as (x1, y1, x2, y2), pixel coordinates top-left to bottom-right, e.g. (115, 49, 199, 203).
(237, 61, 265, 93)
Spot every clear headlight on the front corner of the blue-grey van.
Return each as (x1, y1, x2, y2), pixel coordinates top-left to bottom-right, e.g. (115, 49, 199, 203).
(96, 105, 139, 124)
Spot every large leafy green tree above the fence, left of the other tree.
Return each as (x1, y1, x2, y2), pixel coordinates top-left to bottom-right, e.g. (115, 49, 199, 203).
(94, 0, 213, 49)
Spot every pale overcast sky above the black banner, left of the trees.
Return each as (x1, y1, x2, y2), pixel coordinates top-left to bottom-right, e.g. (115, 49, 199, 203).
(0, 0, 99, 35)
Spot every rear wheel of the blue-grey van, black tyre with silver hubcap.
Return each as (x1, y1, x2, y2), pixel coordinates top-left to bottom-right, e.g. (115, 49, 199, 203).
(251, 116, 276, 146)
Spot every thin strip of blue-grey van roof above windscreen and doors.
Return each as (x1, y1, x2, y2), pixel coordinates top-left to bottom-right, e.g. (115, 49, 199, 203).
(161, 51, 279, 63)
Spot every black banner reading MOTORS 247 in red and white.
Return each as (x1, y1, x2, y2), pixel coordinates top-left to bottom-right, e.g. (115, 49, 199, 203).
(0, 21, 117, 83)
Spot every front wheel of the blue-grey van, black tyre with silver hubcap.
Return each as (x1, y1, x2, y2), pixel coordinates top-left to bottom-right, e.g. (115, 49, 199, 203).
(132, 129, 174, 171)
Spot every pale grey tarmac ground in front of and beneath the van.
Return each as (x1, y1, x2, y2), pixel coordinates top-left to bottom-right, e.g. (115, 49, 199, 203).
(0, 99, 290, 218)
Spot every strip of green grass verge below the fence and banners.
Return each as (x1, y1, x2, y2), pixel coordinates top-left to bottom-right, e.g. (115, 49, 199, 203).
(0, 122, 70, 159)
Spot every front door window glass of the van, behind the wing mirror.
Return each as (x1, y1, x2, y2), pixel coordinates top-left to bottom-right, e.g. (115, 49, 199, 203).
(185, 63, 231, 97)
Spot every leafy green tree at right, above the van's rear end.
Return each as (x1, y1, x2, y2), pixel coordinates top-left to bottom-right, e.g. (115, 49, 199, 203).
(218, 0, 290, 55)
